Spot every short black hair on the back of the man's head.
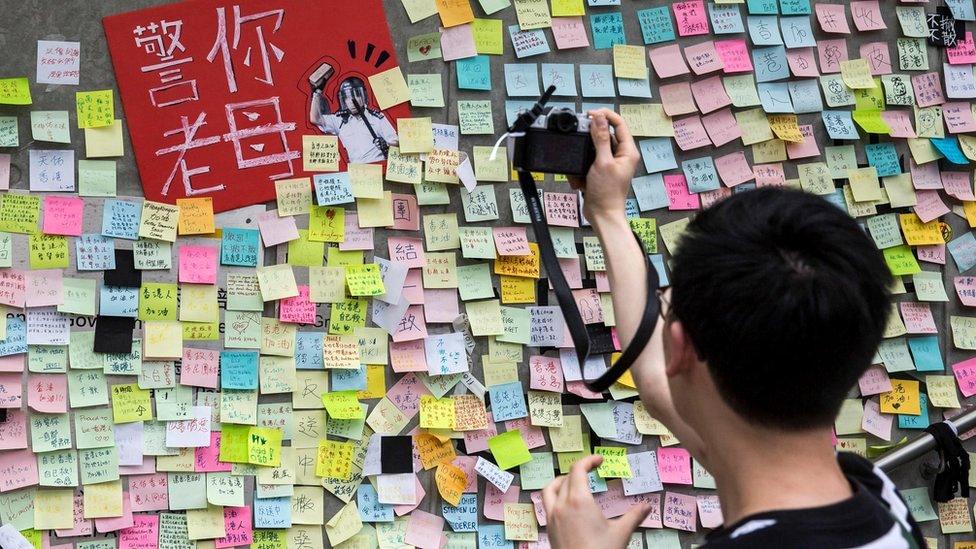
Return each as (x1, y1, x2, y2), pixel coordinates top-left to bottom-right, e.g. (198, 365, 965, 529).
(671, 188, 892, 429)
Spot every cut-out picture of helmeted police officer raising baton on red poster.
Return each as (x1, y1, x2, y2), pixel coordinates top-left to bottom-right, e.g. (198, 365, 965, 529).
(308, 63, 399, 164)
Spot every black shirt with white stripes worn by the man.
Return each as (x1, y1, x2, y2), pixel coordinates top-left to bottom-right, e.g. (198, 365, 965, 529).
(705, 452, 925, 549)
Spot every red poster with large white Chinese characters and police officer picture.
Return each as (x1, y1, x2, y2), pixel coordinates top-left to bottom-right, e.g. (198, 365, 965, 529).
(103, 0, 410, 211)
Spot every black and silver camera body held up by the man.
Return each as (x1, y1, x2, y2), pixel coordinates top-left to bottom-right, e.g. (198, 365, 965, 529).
(512, 107, 600, 177)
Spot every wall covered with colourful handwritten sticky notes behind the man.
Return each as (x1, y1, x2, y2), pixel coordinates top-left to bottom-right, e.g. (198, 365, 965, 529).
(0, 0, 976, 549)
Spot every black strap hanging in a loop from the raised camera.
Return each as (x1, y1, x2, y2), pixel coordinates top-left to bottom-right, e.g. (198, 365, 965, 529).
(518, 170, 660, 393)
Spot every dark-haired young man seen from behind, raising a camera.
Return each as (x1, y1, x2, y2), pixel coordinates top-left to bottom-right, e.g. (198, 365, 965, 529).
(543, 109, 924, 549)
